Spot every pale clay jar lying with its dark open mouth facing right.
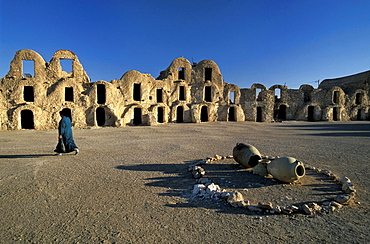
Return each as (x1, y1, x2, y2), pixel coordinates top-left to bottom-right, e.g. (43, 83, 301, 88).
(267, 157, 306, 182)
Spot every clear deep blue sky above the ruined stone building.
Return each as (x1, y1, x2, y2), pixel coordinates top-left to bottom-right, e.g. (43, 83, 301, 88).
(0, 0, 370, 88)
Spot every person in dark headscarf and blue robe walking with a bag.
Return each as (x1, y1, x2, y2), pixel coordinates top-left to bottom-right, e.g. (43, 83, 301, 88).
(54, 110, 80, 156)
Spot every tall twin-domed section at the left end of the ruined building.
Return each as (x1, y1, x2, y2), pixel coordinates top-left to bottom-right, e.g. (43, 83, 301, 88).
(0, 50, 89, 130)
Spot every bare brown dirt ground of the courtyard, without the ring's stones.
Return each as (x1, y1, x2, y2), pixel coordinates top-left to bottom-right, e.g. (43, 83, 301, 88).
(0, 121, 370, 243)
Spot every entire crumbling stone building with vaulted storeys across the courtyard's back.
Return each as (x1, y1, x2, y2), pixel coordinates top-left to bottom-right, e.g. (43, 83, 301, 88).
(0, 49, 370, 130)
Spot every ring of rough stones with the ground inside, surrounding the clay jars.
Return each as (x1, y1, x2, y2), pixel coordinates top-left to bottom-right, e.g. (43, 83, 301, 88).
(188, 155, 359, 215)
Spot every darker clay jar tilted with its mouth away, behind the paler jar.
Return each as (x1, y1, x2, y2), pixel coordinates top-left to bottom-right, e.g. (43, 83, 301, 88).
(233, 143, 261, 168)
